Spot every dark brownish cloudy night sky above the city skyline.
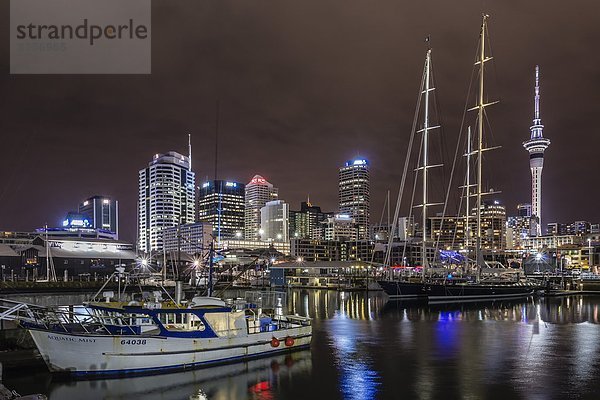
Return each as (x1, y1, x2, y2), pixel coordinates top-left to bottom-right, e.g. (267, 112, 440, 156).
(0, 0, 600, 240)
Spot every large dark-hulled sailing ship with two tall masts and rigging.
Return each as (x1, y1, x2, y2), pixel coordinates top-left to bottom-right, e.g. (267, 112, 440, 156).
(378, 15, 538, 302)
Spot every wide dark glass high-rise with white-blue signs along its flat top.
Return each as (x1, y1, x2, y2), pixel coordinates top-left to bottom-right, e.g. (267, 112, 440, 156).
(198, 180, 245, 242)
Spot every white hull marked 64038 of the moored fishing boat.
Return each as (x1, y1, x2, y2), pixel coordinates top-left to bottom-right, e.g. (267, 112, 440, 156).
(29, 327, 312, 377)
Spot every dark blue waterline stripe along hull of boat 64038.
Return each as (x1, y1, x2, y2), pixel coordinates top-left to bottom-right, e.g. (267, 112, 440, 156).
(65, 343, 310, 379)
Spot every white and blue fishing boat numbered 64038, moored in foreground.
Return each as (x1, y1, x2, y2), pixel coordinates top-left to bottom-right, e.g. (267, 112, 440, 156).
(0, 292, 312, 377)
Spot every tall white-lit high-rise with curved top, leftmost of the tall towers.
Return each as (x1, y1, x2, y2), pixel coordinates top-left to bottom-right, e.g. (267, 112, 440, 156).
(138, 151, 196, 252)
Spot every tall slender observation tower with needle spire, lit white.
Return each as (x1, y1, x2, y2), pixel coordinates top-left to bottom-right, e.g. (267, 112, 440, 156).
(523, 65, 550, 236)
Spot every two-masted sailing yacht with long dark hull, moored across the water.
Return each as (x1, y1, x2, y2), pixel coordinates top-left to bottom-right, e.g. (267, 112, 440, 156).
(378, 15, 538, 302)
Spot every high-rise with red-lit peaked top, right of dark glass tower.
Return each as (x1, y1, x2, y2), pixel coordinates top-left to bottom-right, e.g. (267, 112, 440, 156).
(244, 175, 279, 240)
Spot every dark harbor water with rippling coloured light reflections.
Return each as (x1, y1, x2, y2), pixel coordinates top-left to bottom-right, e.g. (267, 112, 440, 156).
(3, 289, 600, 400)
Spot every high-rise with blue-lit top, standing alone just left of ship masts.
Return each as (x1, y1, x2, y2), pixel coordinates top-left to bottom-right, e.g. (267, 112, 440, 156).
(339, 159, 371, 239)
